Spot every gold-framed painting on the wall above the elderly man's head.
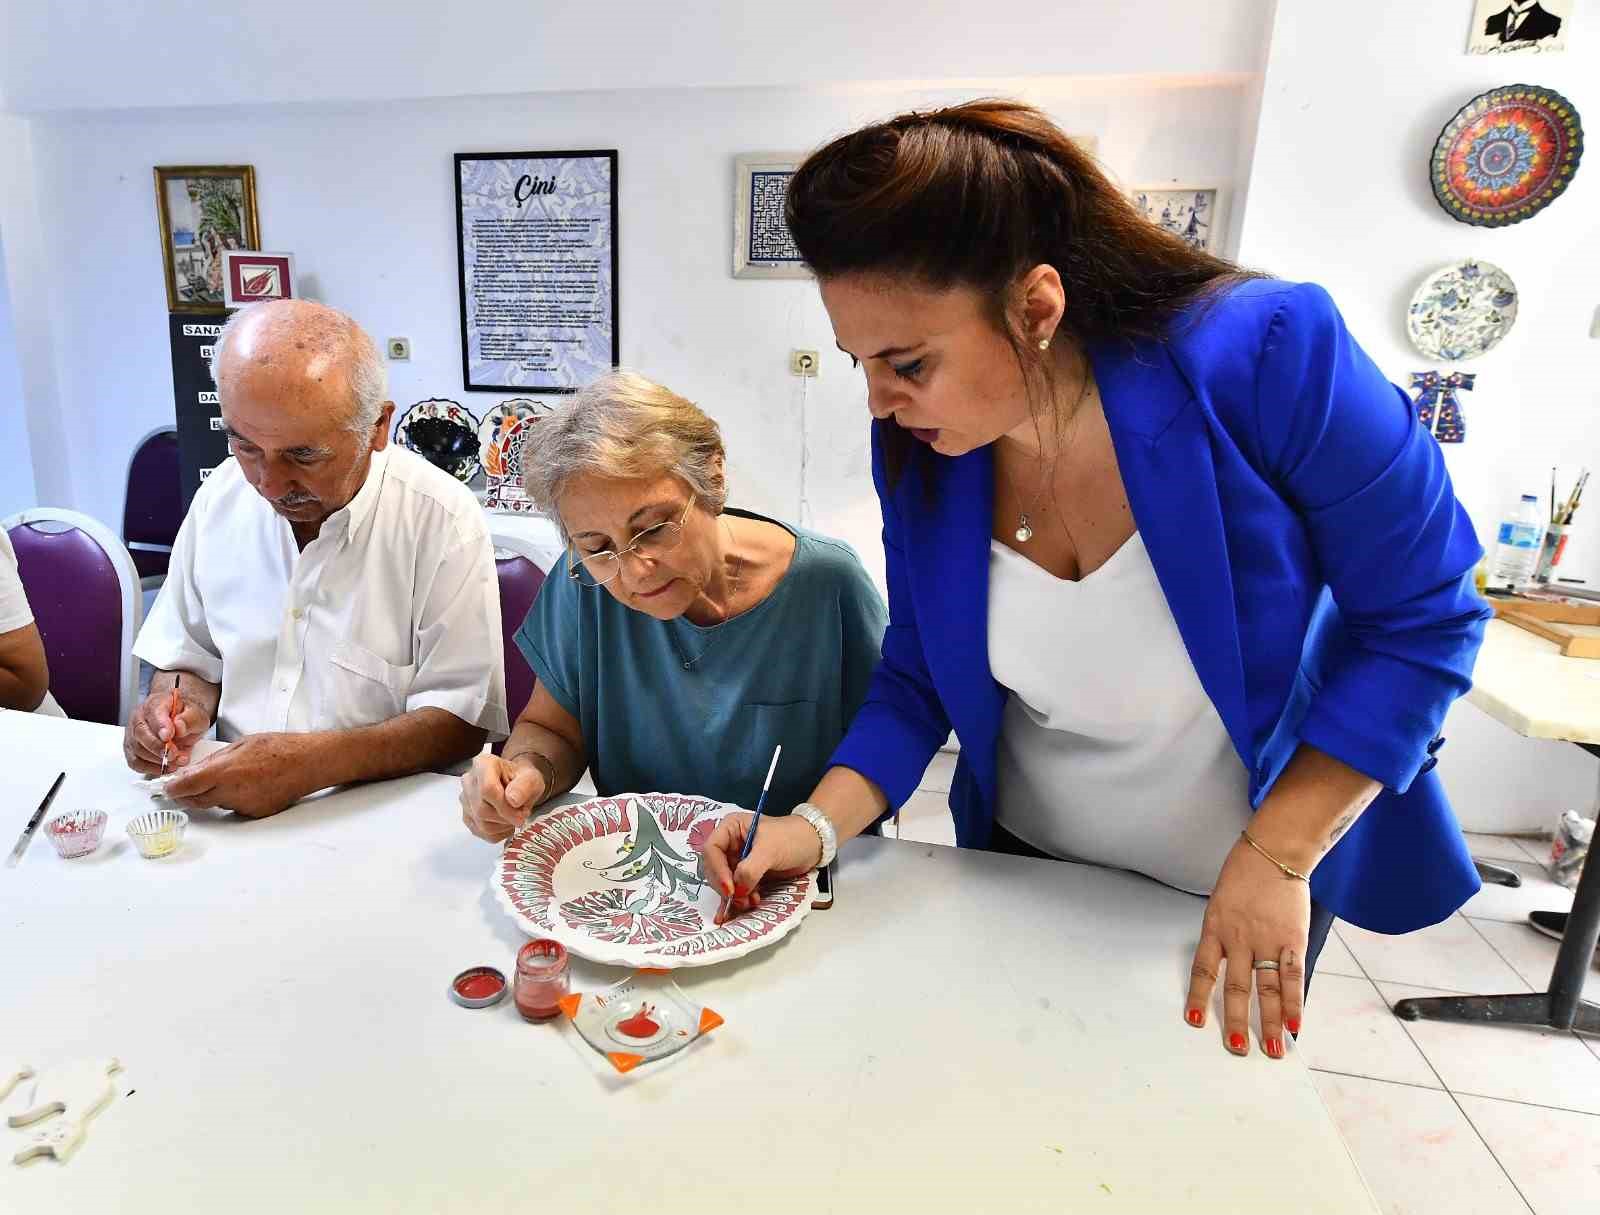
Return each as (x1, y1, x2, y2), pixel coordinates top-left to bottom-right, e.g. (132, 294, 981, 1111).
(155, 165, 261, 312)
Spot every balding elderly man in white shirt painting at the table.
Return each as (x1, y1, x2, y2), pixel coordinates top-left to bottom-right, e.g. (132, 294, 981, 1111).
(123, 299, 507, 818)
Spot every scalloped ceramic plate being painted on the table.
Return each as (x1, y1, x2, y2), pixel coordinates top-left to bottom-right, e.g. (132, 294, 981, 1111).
(494, 792, 816, 968)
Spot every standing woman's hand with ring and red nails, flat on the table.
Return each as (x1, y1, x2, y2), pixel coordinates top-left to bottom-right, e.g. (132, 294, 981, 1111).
(1184, 837, 1310, 1058)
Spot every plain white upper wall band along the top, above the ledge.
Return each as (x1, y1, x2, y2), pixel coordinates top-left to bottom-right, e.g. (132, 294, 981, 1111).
(0, 0, 1270, 112)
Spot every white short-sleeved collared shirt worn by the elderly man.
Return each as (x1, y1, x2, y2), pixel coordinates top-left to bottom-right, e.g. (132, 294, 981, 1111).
(143, 448, 507, 741)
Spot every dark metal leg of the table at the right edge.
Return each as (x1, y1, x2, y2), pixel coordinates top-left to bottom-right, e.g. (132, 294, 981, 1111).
(1394, 743, 1600, 1034)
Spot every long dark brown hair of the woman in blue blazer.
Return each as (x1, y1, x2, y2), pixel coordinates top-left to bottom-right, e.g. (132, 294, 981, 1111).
(784, 99, 1251, 480)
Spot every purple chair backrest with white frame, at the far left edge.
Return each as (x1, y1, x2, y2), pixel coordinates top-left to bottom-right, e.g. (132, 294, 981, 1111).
(0, 506, 144, 725)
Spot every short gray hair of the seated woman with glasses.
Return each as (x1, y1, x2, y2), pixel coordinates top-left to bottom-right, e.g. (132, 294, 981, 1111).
(522, 371, 728, 539)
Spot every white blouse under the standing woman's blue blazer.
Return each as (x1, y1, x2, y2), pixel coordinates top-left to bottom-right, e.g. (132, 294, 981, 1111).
(989, 533, 1250, 895)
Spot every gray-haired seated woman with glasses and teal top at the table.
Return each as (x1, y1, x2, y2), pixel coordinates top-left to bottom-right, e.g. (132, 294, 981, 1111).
(461, 371, 888, 840)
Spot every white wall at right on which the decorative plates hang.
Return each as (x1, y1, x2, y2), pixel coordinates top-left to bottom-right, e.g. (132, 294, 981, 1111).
(1240, 0, 1600, 829)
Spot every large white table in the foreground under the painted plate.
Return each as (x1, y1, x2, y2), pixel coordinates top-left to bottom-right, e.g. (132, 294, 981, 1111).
(0, 712, 1376, 1215)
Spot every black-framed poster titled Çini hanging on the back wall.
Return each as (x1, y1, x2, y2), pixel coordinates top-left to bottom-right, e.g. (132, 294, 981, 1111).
(456, 149, 619, 392)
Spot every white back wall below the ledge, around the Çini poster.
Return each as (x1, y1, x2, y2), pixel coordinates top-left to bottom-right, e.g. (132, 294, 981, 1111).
(18, 78, 1246, 589)
